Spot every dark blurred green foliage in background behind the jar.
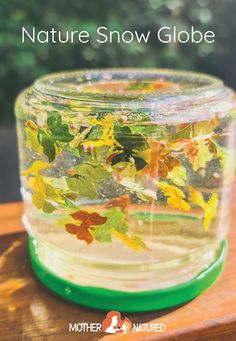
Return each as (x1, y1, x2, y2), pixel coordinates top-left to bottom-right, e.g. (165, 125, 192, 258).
(0, 0, 236, 124)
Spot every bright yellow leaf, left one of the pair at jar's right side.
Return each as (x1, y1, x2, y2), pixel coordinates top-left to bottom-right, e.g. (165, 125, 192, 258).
(155, 182, 190, 211)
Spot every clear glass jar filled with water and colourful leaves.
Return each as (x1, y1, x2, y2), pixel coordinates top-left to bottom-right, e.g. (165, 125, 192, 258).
(16, 69, 235, 310)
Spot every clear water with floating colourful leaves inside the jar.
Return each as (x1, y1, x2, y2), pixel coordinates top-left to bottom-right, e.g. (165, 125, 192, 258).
(15, 71, 235, 291)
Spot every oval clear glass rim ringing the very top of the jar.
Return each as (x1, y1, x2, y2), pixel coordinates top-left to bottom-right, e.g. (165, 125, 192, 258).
(33, 68, 224, 102)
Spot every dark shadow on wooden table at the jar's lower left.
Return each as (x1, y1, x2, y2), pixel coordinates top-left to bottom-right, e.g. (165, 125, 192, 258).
(0, 233, 188, 341)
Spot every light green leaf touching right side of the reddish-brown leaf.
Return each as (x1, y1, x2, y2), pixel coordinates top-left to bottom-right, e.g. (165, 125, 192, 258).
(92, 208, 128, 242)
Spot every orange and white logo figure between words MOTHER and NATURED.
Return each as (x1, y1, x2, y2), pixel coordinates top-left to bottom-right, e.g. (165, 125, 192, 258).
(102, 311, 132, 334)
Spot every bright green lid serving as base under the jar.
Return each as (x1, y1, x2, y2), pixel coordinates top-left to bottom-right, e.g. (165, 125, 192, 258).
(29, 237, 227, 312)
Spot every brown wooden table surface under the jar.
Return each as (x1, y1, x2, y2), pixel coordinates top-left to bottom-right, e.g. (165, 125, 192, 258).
(0, 195, 236, 341)
